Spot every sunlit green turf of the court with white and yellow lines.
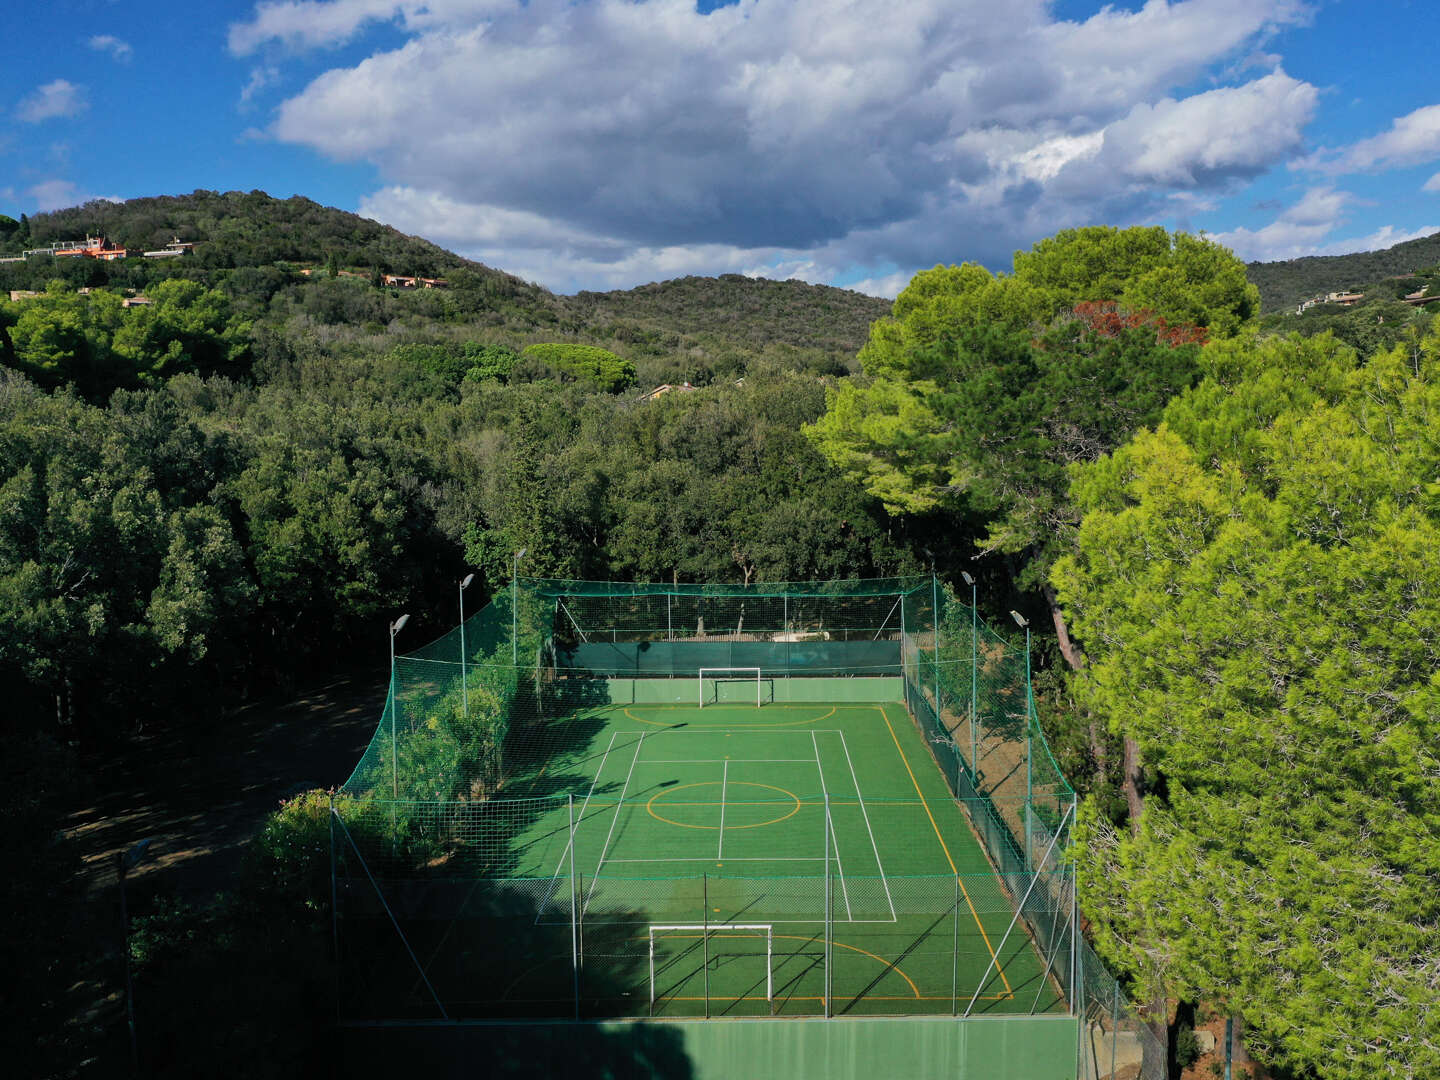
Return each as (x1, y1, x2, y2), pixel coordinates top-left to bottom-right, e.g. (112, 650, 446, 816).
(483, 688, 1061, 1015)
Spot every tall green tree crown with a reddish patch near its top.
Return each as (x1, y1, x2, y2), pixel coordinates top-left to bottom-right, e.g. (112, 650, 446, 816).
(808, 228, 1257, 616)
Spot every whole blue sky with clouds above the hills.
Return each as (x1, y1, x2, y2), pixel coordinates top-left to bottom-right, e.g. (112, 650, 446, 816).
(0, 0, 1440, 297)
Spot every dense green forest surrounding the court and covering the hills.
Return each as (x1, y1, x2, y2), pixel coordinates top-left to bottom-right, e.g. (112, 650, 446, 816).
(0, 192, 1440, 1077)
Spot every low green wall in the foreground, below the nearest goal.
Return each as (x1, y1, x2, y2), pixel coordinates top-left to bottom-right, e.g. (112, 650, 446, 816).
(341, 1017, 1077, 1080)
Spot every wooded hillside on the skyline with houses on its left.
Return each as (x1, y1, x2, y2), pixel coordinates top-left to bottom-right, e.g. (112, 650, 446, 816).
(0, 192, 890, 384)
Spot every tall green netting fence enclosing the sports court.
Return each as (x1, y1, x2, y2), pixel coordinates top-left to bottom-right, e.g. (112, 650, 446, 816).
(331, 576, 1155, 1077)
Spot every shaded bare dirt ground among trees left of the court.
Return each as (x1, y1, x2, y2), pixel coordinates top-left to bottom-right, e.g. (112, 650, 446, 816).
(48, 668, 386, 1077)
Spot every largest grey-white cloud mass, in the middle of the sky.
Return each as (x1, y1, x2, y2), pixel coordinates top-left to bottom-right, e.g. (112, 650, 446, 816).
(230, 0, 1316, 285)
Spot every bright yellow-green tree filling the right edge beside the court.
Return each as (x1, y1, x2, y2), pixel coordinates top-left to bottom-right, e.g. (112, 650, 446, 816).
(1054, 336, 1440, 1080)
